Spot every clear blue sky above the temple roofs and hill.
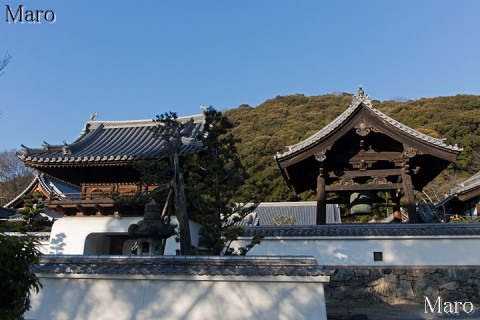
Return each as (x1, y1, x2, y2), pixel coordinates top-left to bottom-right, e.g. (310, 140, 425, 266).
(0, 0, 480, 150)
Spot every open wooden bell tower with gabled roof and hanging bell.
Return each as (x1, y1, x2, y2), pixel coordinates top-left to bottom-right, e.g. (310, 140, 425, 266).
(275, 87, 461, 224)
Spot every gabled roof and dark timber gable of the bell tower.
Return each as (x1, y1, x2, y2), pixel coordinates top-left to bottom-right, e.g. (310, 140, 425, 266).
(276, 89, 461, 193)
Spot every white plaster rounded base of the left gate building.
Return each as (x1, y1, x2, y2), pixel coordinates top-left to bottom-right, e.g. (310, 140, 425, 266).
(44, 217, 200, 255)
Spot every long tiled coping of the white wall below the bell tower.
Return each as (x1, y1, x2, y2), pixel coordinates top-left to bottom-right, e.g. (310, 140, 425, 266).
(244, 223, 480, 237)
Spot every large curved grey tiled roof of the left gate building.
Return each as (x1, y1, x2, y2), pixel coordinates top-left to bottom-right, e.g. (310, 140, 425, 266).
(19, 115, 204, 166)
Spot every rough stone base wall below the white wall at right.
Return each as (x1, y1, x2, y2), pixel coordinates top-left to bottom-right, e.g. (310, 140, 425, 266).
(325, 266, 480, 305)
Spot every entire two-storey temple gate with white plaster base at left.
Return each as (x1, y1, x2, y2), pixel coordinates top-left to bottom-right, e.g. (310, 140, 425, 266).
(15, 114, 205, 255)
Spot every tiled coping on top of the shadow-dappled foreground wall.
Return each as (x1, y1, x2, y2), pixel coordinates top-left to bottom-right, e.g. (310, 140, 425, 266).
(32, 255, 332, 277)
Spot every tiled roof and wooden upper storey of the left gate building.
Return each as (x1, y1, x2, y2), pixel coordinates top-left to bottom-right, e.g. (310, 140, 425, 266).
(16, 115, 204, 216)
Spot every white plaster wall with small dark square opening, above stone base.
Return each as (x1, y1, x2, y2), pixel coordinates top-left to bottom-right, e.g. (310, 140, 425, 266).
(240, 236, 480, 266)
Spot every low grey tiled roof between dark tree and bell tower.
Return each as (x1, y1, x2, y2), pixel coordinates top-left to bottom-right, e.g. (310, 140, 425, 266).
(238, 201, 341, 226)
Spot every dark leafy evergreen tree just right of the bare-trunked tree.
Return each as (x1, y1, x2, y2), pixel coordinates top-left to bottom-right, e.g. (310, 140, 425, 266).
(187, 107, 258, 255)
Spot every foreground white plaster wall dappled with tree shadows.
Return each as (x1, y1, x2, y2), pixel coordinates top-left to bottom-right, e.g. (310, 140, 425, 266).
(26, 275, 326, 320)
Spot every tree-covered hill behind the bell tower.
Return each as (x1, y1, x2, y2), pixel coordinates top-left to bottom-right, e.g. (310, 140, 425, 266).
(225, 93, 480, 201)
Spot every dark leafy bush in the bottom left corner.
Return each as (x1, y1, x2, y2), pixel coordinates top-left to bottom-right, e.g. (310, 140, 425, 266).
(0, 234, 42, 320)
